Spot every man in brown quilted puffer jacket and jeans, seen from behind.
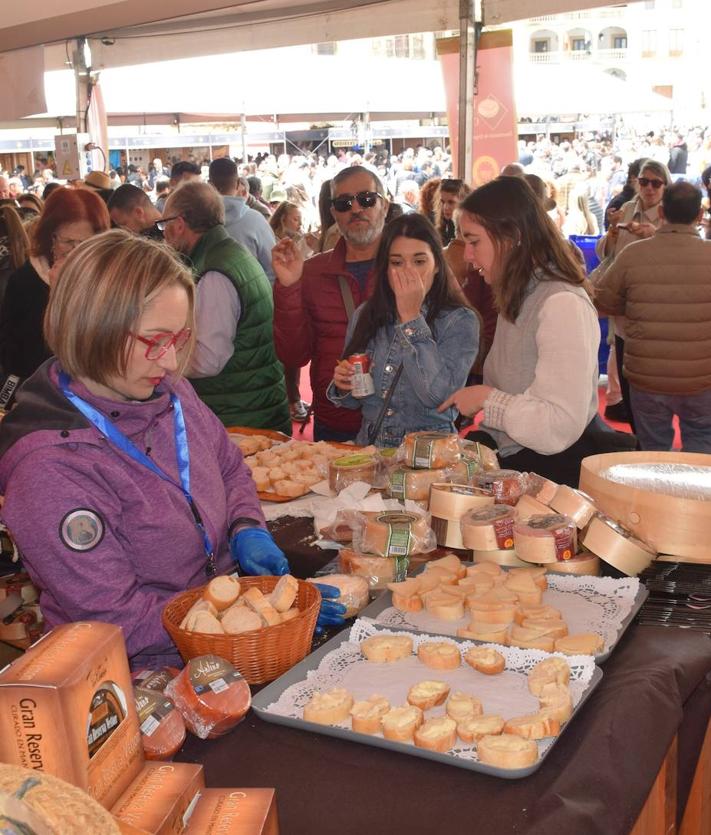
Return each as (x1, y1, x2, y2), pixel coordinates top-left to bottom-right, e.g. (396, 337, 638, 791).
(595, 181, 711, 453)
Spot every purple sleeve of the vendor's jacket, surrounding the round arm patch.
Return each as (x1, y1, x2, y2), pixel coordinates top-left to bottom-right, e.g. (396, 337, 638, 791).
(2, 454, 173, 655)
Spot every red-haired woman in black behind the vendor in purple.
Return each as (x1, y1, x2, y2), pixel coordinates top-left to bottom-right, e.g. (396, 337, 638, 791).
(0, 188, 111, 405)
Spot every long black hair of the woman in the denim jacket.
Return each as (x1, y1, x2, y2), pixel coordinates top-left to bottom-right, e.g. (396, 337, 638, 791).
(343, 212, 462, 357)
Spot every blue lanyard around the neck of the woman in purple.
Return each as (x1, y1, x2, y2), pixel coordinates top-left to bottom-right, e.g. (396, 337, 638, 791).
(59, 371, 217, 577)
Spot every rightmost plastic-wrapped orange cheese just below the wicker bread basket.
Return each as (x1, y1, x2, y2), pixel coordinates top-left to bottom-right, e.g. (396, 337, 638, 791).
(165, 655, 252, 739)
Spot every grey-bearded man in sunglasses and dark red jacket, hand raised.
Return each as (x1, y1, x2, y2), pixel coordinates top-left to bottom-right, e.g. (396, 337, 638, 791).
(272, 159, 388, 441)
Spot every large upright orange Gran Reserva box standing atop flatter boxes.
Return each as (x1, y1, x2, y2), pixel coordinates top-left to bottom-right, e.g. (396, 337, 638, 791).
(0, 621, 144, 809)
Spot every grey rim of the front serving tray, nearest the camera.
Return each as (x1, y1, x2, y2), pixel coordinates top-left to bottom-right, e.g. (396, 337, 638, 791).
(252, 624, 602, 780)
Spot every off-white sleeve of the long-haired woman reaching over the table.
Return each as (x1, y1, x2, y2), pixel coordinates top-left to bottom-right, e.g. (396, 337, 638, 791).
(483, 292, 600, 455)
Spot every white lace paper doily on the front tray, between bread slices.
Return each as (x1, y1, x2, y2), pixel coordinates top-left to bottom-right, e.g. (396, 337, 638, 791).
(267, 619, 595, 764)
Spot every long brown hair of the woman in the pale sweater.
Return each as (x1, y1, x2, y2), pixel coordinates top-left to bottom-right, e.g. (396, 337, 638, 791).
(459, 177, 592, 322)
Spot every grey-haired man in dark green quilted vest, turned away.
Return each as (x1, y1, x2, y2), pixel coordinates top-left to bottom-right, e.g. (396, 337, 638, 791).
(163, 181, 291, 435)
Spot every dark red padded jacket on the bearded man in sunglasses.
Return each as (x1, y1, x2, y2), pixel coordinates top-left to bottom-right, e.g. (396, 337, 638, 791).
(274, 238, 374, 433)
